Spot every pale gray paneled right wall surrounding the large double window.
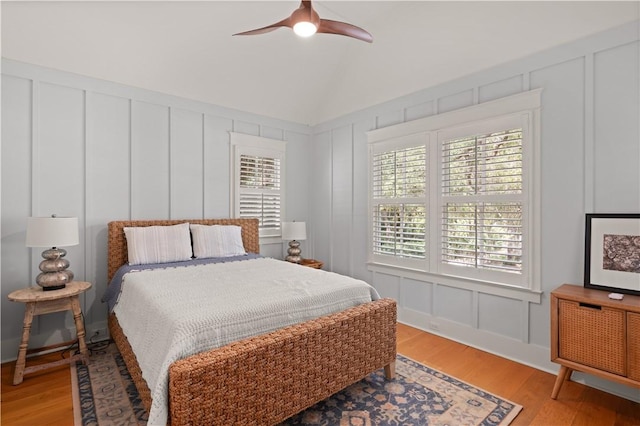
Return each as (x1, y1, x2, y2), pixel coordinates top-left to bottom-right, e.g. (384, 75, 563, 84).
(311, 22, 640, 399)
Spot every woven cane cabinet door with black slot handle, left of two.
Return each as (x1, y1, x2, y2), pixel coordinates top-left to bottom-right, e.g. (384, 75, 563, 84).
(558, 300, 626, 376)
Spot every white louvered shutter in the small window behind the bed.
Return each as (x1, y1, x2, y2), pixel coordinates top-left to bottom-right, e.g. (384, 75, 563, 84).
(239, 154, 282, 236)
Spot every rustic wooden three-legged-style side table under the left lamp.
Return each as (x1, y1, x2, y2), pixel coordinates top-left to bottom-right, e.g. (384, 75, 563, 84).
(7, 281, 91, 385)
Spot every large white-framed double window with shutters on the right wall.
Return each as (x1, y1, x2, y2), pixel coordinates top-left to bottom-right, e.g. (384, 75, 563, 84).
(368, 90, 540, 290)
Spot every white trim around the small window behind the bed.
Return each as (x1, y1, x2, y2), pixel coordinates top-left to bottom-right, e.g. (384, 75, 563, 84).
(229, 132, 287, 244)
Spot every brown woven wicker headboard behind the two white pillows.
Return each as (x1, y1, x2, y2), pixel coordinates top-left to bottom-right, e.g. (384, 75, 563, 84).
(107, 219, 260, 281)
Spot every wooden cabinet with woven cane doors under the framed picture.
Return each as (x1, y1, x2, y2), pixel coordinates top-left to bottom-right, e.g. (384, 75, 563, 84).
(551, 284, 640, 399)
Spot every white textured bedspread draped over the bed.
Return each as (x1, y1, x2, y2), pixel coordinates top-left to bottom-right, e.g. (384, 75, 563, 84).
(114, 258, 379, 425)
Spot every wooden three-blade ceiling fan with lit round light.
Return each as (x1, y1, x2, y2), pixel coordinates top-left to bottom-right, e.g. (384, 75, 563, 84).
(234, 0, 373, 43)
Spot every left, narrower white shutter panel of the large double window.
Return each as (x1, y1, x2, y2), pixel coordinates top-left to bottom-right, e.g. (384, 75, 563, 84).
(371, 145, 427, 259)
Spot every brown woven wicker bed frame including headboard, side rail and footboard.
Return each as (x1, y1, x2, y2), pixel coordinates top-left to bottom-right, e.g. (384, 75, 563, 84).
(108, 219, 396, 425)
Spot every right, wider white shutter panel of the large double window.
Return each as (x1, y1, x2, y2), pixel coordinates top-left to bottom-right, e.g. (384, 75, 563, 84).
(441, 128, 524, 273)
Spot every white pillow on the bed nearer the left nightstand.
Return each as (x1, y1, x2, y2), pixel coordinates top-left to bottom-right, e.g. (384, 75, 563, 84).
(124, 223, 192, 265)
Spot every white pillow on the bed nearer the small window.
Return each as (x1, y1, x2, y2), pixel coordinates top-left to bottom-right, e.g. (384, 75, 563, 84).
(190, 223, 247, 259)
